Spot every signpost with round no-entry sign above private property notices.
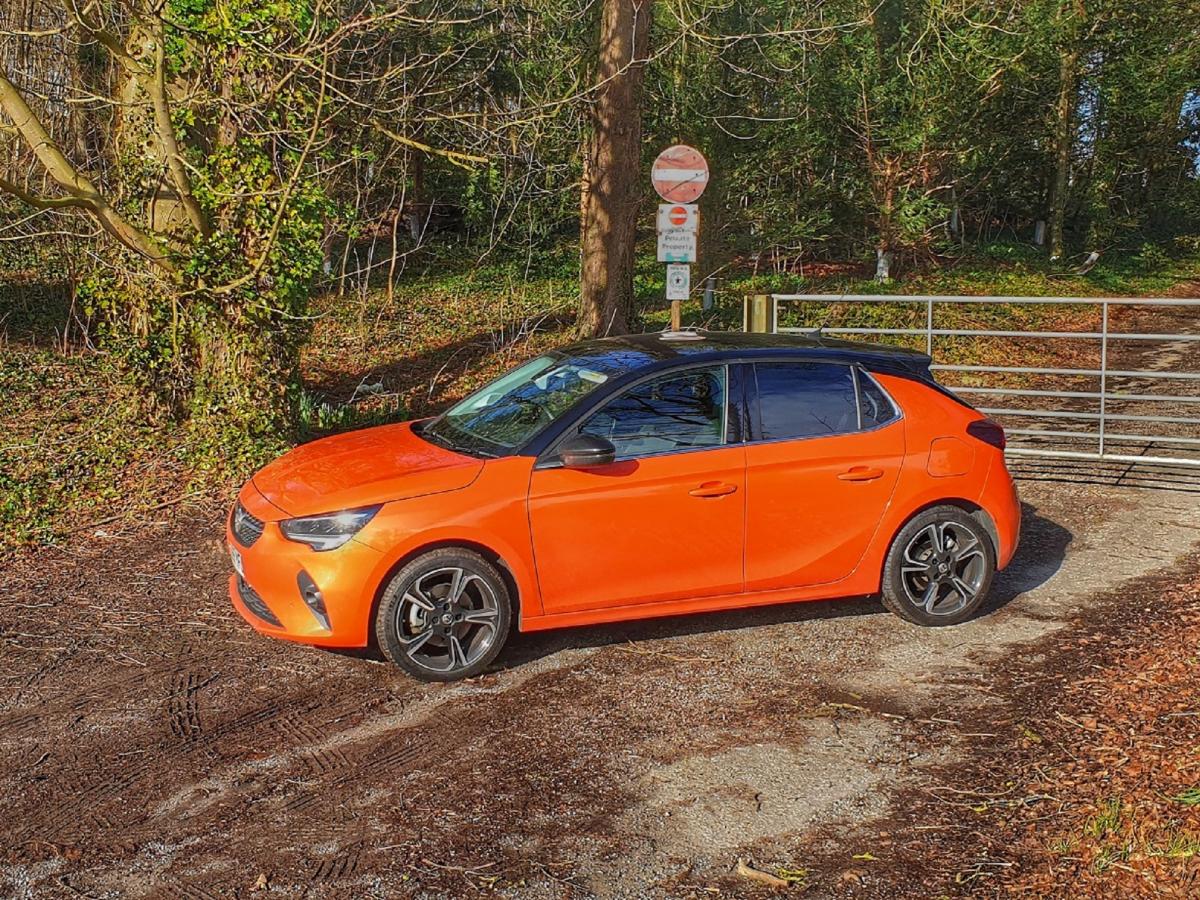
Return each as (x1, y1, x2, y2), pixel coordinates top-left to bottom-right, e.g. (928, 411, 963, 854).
(650, 144, 708, 331)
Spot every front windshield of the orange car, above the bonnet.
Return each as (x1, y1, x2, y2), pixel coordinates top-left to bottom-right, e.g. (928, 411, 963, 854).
(421, 354, 614, 456)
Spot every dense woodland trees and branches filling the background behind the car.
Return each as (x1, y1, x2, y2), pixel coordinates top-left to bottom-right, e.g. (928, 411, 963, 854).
(0, 0, 1200, 432)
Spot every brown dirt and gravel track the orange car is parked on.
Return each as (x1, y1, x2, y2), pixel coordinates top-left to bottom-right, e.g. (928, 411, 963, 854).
(0, 464, 1200, 898)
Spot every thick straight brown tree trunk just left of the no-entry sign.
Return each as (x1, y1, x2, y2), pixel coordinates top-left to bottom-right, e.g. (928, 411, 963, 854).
(578, 0, 650, 336)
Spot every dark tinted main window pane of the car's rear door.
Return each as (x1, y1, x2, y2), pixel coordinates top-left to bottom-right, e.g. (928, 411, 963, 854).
(755, 362, 858, 440)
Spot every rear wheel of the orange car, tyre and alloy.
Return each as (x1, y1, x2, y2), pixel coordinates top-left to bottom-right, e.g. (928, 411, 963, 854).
(882, 506, 996, 625)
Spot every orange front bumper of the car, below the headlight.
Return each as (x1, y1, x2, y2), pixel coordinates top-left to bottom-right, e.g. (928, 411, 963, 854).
(226, 484, 382, 647)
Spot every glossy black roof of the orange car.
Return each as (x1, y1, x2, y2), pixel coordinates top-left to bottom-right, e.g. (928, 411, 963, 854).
(559, 331, 930, 376)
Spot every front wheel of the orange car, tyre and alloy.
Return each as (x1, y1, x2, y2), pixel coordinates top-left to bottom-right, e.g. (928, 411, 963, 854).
(374, 547, 512, 682)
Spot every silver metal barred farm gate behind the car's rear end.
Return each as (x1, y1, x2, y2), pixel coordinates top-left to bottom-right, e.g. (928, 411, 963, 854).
(746, 294, 1200, 472)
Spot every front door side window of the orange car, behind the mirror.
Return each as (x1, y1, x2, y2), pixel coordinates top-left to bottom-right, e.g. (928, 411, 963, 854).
(580, 366, 726, 458)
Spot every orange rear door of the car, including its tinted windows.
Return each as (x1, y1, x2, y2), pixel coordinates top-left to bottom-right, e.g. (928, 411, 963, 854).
(746, 361, 905, 590)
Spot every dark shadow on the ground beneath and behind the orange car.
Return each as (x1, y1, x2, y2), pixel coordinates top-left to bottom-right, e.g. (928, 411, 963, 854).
(497, 503, 1074, 667)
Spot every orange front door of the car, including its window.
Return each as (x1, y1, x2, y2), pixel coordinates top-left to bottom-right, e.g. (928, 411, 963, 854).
(529, 365, 745, 614)
